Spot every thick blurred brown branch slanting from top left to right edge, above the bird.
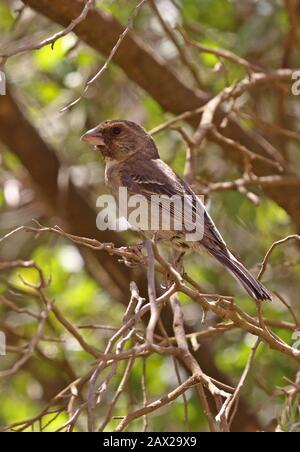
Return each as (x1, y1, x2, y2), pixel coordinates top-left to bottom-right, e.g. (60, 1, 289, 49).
(23, 0, 300, 231)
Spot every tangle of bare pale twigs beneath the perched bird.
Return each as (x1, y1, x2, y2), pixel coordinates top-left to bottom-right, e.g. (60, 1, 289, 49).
(0, 224, 300, 431)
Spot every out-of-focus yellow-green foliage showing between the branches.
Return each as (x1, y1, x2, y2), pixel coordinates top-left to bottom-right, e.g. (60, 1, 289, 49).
(0, 0, 300, 432)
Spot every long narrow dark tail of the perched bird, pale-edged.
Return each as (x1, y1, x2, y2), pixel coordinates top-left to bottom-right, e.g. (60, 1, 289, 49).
(209, 249, 272, 301)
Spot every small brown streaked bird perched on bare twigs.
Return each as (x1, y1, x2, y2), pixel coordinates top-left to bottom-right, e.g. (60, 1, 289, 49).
(81, 120, 272, 301)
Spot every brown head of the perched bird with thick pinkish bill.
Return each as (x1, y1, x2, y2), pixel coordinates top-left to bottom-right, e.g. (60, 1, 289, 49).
(81, 120, 158, 161)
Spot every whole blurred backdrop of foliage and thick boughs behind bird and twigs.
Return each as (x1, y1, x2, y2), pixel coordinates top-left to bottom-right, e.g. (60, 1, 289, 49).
(0, 0, 300, 431)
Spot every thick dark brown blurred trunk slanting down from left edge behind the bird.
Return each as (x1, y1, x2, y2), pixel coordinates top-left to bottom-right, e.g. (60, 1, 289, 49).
(0, 89, 261, 431)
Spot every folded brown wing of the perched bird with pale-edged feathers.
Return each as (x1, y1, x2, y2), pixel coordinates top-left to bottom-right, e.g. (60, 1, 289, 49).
(121, 159, 227, 252)
